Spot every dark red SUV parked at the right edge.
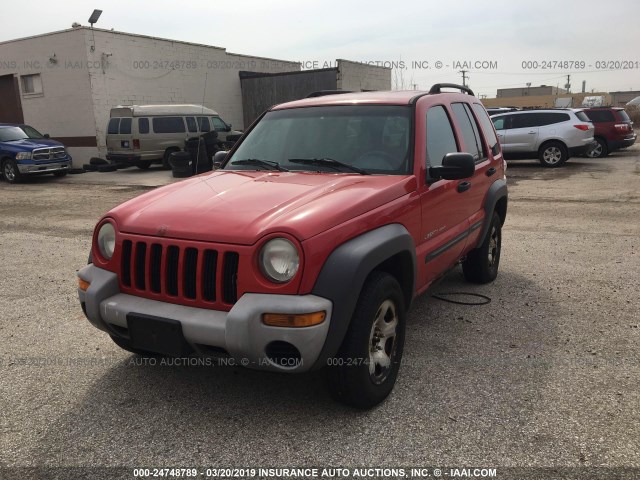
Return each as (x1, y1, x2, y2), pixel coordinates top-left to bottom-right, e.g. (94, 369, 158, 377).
(583, 107, 636, 158)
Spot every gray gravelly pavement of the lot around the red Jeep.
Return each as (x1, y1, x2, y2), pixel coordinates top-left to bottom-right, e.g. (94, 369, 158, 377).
(0, 147, 640, 479)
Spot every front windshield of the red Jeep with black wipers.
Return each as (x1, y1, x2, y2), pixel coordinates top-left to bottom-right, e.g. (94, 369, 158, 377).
(224, 105, 413, 175)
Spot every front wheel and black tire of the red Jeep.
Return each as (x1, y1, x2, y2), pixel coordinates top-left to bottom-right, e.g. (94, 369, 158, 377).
(326, 272, 406, 409)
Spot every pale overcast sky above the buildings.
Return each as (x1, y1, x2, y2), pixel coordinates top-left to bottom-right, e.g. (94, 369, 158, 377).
(0, 0, 640, 97)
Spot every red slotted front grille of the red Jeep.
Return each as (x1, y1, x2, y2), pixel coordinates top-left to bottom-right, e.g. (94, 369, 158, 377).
(119, 239, 240, 308)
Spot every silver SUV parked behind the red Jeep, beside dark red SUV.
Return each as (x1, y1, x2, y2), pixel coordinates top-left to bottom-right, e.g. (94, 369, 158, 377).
(491, 109, 596, 167)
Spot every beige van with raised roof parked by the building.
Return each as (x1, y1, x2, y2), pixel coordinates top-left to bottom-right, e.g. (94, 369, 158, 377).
(106, 105, 242, 169)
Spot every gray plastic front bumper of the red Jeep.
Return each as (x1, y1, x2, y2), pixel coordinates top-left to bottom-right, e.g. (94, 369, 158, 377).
(78, 264, 332, 372)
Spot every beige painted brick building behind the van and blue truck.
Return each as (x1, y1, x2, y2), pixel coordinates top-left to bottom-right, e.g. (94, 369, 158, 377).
(0, 27, 300, 166)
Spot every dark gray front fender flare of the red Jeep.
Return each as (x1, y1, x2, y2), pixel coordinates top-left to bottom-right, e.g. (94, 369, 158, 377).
(311, 223, 416, 369)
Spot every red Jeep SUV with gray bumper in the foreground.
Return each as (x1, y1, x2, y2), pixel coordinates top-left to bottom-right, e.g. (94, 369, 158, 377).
(78, 84, 507, 408)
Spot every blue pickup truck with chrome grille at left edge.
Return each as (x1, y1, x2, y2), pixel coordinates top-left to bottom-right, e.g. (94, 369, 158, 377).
(0, 123, 71, 183)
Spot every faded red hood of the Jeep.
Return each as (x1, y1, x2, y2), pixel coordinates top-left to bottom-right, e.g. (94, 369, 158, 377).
(107, 171, 417, 245)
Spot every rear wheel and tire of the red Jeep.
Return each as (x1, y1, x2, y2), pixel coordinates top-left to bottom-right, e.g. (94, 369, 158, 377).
(462, 212, 502, 283)
